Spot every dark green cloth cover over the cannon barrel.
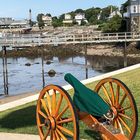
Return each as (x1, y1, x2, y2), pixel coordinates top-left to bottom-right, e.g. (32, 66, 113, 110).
(64, 73, 110, 117)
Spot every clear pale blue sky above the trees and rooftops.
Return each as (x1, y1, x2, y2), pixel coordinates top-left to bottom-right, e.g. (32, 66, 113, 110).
(0, 0, 126, 20)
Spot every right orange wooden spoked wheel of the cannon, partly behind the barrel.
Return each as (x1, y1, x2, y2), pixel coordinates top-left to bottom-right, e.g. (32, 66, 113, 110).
(95, 78, 138, 140)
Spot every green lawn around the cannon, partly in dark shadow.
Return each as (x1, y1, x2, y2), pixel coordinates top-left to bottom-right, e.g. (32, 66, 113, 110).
(0, 68, 140, 140)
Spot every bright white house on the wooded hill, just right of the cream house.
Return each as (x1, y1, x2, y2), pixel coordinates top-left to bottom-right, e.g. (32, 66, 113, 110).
(75, 13, 88, 25)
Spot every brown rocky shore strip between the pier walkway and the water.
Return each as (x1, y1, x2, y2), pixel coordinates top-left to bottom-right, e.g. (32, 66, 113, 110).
(0, 44, 140, 58)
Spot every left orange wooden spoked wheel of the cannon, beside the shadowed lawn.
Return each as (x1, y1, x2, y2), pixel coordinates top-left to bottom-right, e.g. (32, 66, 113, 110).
(36, 85, 79, 140)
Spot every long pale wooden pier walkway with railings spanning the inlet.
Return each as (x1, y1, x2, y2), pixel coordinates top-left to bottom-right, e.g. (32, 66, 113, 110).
(0, 32, 140, 47)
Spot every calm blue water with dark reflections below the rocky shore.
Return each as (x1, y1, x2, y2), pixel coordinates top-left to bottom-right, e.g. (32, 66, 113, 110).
(0, 56, 139, 95)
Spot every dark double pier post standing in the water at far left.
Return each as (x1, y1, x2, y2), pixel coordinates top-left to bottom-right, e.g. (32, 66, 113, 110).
(2, 46, 8, 95)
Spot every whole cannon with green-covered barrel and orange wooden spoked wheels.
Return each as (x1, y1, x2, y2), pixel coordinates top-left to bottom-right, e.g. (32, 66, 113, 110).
(36, 73, 138, 140)
